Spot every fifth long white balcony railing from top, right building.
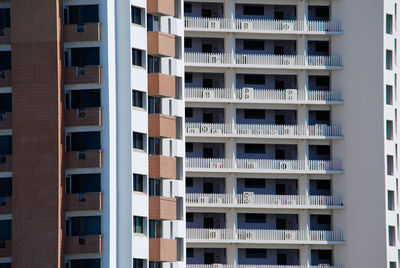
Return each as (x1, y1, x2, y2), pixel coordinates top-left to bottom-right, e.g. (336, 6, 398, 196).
(186, 158, 343, 174)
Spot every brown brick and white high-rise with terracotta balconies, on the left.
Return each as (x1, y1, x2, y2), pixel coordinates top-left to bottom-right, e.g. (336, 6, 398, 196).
(0, 0, 185, 268)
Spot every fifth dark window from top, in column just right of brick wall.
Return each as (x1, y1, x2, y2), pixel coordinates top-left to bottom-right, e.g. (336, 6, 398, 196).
(66, 173, 101, 194)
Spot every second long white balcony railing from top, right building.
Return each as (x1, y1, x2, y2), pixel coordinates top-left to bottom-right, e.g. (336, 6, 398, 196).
(185, 52, 342, 70)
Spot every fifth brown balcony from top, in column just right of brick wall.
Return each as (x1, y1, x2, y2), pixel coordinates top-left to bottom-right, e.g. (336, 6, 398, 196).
(65, 193, 102, 211)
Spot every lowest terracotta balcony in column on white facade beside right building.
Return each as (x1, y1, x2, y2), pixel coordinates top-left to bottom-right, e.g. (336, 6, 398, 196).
(149, 238, 178, 262)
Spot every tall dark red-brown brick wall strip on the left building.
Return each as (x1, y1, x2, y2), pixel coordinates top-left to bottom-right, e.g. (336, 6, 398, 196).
(10, 0, 63, 268)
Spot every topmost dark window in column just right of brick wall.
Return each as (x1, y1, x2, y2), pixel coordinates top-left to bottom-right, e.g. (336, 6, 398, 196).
(64, 5, 99, 24)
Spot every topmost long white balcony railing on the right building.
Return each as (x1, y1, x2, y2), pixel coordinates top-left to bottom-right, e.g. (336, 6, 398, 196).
(185, 17, 342, 33)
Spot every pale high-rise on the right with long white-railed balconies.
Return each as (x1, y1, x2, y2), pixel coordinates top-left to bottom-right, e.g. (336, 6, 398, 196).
(184, 0, 400, 268)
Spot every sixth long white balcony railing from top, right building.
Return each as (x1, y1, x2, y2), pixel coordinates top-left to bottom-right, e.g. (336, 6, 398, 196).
(186, 192, 343, 208)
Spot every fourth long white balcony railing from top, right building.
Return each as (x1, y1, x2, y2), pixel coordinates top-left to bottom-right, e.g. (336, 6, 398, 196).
(185, 123, 342, 138)
